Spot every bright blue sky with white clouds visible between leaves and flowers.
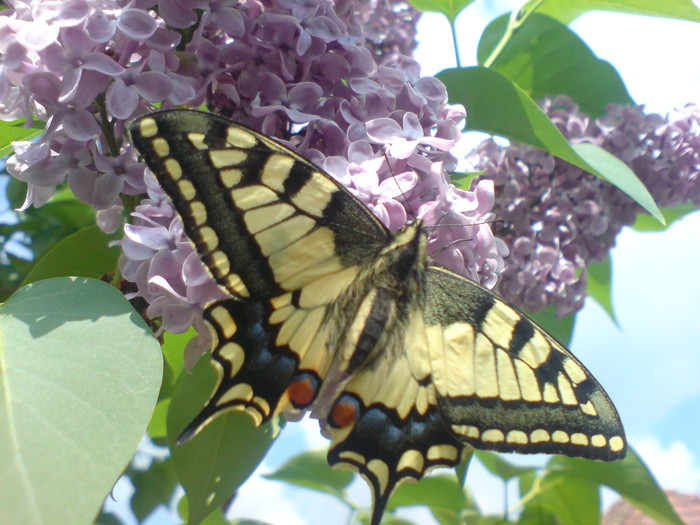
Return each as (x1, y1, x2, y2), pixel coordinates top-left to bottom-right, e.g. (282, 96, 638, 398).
(215, 1, 700, 525)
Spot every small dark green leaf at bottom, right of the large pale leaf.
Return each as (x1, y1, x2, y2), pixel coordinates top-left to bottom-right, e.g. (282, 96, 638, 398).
(128, 457, 177, 523)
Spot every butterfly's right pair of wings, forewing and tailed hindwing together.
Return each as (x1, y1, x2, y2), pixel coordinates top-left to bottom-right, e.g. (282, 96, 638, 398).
(325, 266, 626, 524)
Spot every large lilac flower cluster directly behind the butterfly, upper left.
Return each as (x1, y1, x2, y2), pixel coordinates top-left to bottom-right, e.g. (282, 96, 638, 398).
(0, 0, 503, 360)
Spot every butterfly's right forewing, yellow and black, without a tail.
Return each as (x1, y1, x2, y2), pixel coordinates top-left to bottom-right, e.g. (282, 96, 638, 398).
(426, 267, 625, 460)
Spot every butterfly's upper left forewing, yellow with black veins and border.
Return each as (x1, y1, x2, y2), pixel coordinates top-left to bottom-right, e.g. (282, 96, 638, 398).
(131, 110, 390, 298)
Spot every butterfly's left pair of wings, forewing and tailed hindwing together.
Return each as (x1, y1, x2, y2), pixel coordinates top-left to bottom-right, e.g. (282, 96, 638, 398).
(131, 110, 391, 441)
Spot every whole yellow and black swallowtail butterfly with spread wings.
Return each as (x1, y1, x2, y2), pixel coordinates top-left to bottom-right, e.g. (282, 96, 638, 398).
(131, 110, 626, 525)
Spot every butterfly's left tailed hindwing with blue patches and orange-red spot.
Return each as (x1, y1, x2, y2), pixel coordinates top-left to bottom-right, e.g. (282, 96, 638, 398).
(178, 293, 329, 442)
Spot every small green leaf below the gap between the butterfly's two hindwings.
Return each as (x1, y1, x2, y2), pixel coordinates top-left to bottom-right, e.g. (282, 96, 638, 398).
(265, 450, 354, 500)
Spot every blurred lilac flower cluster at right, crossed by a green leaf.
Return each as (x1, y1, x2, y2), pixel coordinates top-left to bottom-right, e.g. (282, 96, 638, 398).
(468, 97, 700, 315)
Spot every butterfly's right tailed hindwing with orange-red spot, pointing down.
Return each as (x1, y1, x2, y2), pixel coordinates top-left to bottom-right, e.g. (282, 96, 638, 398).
(325, 302, 464, 525)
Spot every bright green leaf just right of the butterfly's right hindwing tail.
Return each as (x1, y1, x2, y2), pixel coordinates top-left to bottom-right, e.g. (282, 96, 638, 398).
(387, 475, 476, 523)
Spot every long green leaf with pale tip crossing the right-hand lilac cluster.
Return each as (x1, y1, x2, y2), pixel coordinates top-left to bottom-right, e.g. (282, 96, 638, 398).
(437, 67, 663, 222)
